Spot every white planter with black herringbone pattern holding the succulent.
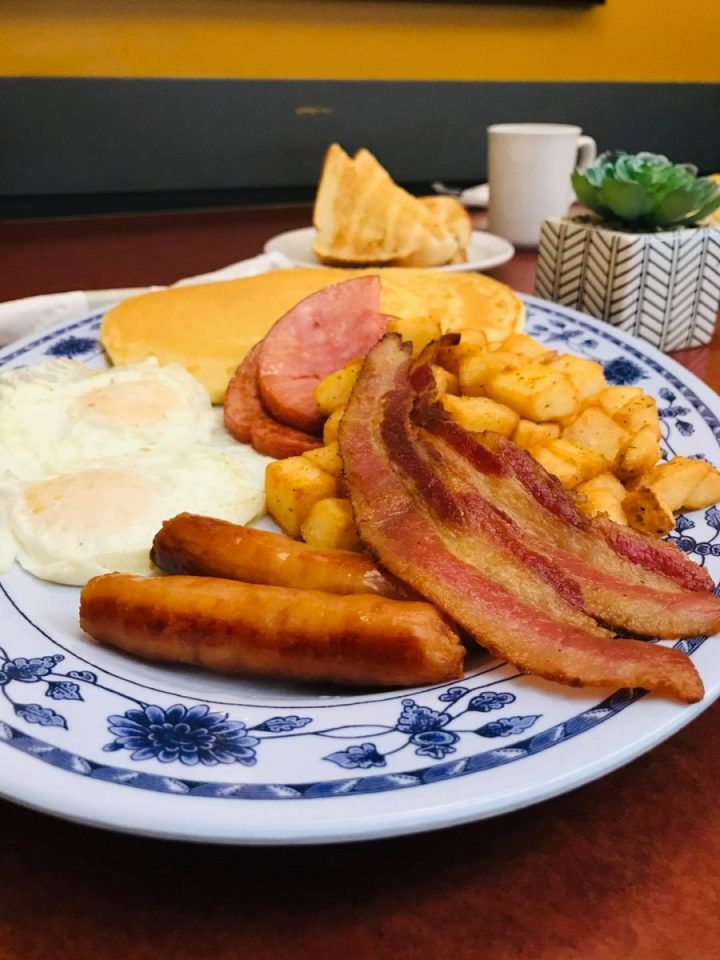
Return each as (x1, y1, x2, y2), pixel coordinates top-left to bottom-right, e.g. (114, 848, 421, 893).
(535, 217, 720, 351)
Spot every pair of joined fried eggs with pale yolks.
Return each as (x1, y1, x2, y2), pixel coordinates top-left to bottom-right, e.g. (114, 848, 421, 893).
(0, 360, 270, 585)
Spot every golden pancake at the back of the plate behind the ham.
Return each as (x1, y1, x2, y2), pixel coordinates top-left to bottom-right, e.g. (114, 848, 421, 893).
(100, 267, 524, 403)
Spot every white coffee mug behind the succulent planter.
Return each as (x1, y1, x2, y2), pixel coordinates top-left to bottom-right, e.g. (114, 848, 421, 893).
(488, 123, 597, 247)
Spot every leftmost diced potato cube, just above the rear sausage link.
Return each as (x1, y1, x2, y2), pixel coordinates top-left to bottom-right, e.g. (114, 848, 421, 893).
(265, 456, 337, 537)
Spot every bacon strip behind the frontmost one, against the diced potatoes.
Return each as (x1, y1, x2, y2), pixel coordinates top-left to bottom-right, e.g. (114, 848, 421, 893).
(411, 350, 720, 638)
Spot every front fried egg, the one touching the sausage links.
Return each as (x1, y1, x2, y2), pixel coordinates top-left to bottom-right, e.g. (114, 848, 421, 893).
(8, 445, 265, 585)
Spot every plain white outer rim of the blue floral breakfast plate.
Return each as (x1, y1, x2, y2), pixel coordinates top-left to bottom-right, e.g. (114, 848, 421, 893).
(0, 296, 720, 845)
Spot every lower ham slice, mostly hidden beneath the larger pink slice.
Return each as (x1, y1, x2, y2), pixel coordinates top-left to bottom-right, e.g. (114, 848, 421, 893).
(224, 344, 322, 459)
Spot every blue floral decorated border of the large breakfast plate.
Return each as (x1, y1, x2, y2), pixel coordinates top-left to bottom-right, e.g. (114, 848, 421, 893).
(0, 298, 720, 832)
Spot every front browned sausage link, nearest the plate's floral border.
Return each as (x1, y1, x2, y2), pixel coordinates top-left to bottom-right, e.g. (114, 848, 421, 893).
(80, 573, 464, 687)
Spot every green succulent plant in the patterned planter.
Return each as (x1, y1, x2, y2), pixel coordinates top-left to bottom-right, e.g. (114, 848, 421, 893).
(572, 151, 720, 231)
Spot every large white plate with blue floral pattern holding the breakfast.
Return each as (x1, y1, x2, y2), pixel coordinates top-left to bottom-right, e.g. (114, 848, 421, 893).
(0, 298, 720, 844)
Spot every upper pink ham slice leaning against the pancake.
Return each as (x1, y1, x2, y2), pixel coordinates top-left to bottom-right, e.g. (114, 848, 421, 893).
(258, 276, 387, 433)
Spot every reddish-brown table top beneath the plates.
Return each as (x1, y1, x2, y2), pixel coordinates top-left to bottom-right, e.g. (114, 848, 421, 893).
(0, 207, 720, 960)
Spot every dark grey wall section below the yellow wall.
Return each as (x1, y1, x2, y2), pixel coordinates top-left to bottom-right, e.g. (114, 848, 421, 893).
(0, 77, 720, 217)
